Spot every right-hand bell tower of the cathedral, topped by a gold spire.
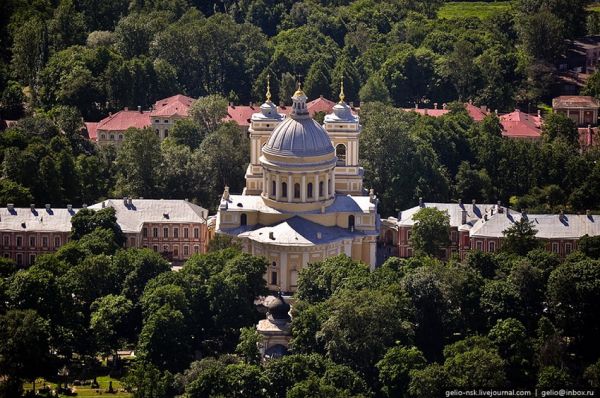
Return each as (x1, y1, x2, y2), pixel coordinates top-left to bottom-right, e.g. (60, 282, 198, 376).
(323, 80, 365, 195)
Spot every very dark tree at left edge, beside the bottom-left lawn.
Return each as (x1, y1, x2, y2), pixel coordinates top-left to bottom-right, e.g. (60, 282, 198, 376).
(0, 310, 51, 388)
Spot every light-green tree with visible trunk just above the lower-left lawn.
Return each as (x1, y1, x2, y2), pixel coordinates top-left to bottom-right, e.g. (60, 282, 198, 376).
(90, 294, 133, 363)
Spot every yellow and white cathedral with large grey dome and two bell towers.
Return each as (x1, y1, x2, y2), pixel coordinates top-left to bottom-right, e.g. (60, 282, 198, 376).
(216, 81, 380, 292)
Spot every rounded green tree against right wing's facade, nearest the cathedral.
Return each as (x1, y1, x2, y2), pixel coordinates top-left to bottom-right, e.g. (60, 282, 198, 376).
(410, 207, 450, 256)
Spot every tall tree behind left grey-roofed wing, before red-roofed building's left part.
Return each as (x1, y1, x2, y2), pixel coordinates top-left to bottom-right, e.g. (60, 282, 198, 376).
(115, 128, 162, 198)
